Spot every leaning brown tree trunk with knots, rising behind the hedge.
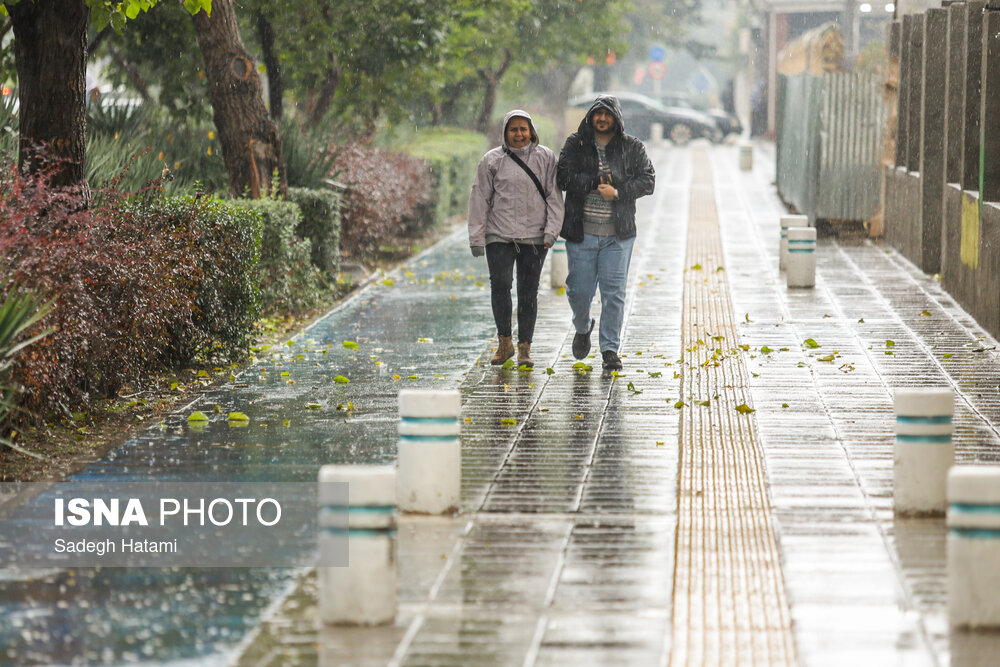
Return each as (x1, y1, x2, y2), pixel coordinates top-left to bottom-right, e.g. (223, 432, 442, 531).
(191, 0, 288, 199)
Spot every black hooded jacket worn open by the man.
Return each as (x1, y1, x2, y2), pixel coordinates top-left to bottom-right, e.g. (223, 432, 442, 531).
(556, 95, 656, 243)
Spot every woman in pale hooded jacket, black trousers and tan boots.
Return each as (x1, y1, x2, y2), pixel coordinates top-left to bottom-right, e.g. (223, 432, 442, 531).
(469, 109, 563, 368)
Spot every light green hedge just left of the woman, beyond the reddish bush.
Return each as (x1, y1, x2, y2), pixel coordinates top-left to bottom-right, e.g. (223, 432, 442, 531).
(401, 127, 489, 224)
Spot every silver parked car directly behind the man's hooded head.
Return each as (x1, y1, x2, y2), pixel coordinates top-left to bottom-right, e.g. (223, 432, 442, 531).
(567, 92, 722, 146)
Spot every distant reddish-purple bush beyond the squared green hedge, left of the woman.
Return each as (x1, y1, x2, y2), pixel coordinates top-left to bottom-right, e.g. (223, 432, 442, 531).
(335, 145, 434, 260)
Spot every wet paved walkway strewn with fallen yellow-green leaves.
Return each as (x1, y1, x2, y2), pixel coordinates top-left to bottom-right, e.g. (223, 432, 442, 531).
(0, 144, 1000, 666)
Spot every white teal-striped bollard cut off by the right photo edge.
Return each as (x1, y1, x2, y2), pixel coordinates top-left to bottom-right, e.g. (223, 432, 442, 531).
(948, 465, 1000, 628)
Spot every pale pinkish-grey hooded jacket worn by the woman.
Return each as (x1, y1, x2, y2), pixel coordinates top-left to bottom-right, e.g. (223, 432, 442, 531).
(469, 109, 563, 247)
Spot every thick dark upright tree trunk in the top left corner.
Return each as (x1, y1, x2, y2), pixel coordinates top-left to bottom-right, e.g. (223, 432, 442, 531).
(7, 0, 90, 185)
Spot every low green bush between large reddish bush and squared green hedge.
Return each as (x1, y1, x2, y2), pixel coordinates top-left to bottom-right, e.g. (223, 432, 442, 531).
(235, 198, 324, 313)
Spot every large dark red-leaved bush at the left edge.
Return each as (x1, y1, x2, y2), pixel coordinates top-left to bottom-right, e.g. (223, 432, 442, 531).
(0, 167, 259, 416)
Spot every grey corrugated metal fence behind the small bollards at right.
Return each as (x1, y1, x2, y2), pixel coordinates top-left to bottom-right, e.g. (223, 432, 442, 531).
(776, 74, 887, 220)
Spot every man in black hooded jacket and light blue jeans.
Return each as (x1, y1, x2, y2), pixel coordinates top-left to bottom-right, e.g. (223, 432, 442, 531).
(556, 95, 655, 370)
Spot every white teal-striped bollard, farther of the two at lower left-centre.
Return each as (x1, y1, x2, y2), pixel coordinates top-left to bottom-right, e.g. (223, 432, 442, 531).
(396, 389, 462, 514)
